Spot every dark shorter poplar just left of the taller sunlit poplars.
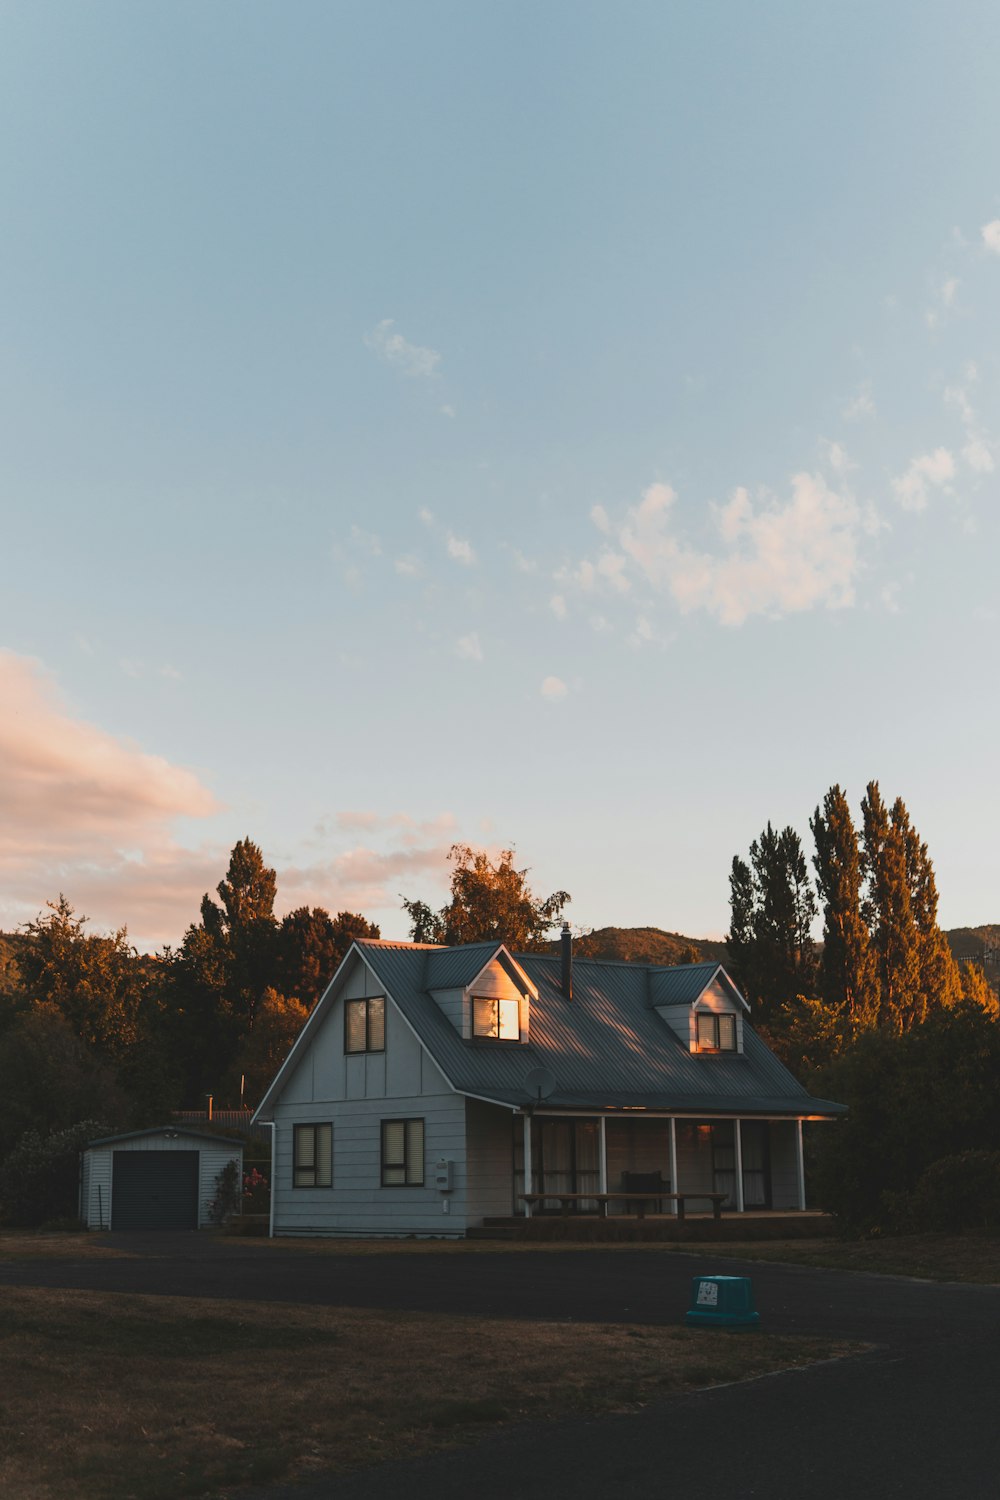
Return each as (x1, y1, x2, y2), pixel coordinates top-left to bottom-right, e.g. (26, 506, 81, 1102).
(727, 824, 816, 1020)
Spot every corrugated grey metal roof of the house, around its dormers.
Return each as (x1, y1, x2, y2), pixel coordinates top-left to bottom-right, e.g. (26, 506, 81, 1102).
(357, 939, 844, 1115)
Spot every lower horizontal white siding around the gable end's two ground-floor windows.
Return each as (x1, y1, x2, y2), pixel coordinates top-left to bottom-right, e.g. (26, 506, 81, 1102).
(271, 1092, 468, 1235)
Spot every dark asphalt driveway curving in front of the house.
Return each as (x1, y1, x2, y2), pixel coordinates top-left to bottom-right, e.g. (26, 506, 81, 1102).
(0, 1235, 1000, 1500)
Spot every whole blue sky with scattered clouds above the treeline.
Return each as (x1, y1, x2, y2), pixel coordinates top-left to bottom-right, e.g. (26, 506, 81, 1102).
(0, 0, 1000, 948)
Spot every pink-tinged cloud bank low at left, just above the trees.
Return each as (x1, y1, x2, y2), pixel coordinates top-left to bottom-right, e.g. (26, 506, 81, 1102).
(0, 651, 457, 948)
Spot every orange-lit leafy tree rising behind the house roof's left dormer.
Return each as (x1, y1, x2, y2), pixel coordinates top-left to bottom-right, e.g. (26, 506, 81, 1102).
(403, 843, 570, 953)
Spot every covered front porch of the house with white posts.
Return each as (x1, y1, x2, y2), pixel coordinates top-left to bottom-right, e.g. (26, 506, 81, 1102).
(511, 1109, 807, 1218)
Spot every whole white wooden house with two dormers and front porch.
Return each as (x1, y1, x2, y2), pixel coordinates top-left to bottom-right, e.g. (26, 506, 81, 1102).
(255, 932, 844, 1236)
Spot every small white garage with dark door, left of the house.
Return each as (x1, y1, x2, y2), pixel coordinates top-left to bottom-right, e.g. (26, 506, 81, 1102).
(79, 1125, 243, 1230)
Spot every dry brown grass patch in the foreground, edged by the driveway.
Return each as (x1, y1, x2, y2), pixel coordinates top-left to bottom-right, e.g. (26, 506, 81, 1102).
(0, 1287, 862, 1500)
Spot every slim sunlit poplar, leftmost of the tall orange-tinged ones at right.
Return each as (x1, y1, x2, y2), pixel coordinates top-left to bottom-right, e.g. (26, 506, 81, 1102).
(810, 786, 879, 1023)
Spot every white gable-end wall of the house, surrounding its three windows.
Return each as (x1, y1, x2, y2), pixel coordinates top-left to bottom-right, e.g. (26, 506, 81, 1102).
(271, 956, 466, 1235)
